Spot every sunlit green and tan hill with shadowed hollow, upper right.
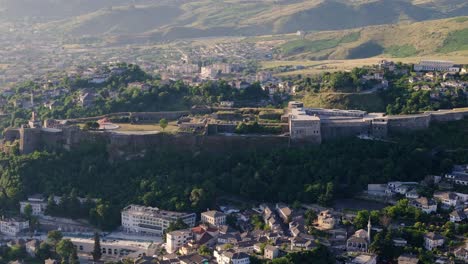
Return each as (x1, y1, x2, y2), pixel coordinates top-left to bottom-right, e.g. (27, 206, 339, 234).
(272, 17, 468, 60)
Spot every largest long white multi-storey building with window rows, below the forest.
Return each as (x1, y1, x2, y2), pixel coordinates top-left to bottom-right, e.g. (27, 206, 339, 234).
(121, 204, 196, 236)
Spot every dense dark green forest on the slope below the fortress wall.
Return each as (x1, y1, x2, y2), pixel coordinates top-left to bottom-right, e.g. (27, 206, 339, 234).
(0, 120, 468, 229)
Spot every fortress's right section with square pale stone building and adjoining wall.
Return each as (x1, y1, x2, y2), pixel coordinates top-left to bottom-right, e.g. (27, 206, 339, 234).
(283, 102, 468, 143)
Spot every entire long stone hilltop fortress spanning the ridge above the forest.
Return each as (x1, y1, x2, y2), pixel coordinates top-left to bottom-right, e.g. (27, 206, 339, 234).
(1, 102, 468, 158)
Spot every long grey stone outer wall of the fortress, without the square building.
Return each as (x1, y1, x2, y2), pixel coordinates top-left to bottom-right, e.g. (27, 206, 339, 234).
(9, 109, 468, 156)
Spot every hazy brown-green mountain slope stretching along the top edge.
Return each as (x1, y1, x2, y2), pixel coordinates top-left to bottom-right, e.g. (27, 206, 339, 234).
(6, 0, 468, 40)
